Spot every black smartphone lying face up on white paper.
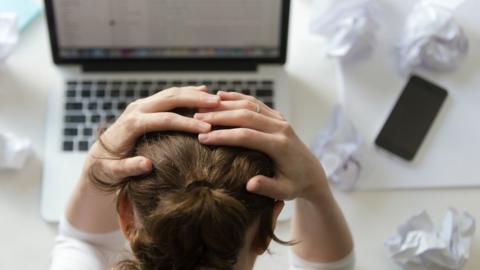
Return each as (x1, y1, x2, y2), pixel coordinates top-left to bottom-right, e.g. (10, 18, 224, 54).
(375, 75, 448, 161)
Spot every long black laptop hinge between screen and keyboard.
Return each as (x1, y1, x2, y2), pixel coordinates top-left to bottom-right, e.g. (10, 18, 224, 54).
(82, 61, 258, 72)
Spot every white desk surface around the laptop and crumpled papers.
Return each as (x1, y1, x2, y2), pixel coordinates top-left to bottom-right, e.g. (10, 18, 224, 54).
(0, 0, 480, 270)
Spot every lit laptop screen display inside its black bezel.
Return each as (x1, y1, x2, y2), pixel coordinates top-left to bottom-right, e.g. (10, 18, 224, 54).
(54, 0, 282, 59)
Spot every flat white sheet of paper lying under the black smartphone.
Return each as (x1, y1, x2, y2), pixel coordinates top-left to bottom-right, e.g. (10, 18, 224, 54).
(339, 0, 480, 189)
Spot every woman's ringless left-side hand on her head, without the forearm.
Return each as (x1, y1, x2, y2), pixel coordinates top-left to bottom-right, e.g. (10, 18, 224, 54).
(86, 86, 220, 184)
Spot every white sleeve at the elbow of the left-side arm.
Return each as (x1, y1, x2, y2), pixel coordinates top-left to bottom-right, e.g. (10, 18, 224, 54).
(50, 218, 131, 270)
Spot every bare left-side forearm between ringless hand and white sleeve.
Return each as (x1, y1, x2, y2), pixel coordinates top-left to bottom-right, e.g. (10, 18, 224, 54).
(65, 150, 119, 233)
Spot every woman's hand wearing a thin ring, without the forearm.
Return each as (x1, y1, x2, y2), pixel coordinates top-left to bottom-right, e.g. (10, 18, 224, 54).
(194, 92, 329, 200)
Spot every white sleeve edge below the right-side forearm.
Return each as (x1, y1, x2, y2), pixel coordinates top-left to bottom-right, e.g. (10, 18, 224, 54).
(289, 249, 355, 270)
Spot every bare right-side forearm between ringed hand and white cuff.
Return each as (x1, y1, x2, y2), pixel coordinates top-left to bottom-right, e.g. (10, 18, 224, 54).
(292, 172, 353, 262)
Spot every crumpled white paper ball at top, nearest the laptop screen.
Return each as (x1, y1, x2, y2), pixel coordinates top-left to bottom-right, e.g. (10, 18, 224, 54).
(310, 0, 380, 58)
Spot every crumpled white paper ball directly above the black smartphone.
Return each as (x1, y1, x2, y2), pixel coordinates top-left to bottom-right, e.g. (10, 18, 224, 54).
(398, 0, 468, 74)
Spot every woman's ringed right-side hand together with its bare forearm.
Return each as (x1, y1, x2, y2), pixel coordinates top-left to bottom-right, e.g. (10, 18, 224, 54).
(195, 92, 353, 263)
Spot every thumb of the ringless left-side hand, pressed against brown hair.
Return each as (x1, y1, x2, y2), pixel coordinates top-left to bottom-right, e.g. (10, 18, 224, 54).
(94, 156, 152, 180)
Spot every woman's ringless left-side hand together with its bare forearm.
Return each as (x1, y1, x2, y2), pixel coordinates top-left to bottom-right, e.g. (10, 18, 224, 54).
(66, 87, 220, 233)
